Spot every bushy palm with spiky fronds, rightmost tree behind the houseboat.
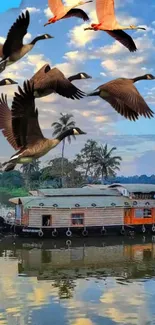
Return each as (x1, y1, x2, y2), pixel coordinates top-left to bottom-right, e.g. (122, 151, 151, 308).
(93, 144, 122, 181)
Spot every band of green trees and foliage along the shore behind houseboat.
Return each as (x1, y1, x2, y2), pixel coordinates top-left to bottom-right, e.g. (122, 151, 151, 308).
(0, 139, 155, 202)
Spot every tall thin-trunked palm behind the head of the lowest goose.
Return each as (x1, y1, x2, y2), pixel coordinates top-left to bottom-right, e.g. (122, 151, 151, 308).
(51, 113, 76, 180)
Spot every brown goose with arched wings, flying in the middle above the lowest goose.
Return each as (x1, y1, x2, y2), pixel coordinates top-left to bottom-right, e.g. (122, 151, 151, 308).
(30, 64, 91, 99)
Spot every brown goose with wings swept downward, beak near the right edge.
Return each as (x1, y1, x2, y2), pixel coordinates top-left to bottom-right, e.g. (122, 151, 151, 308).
(88, 74, 155, 121)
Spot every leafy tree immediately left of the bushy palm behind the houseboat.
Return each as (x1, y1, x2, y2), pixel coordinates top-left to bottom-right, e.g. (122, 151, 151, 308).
(75, 139, 99, 179)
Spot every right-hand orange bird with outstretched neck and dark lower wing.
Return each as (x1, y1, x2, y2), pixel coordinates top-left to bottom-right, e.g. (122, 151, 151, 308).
(84, 0, 145, 52)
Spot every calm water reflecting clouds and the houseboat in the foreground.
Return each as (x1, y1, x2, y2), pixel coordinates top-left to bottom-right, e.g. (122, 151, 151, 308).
(0, 237, 155, 325)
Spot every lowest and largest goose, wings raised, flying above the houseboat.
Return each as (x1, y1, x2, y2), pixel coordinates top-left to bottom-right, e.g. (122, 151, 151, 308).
(0, 81, 85, 171)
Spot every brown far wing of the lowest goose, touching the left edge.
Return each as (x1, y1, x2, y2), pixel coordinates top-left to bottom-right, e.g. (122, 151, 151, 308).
(0, 94, 19, 150)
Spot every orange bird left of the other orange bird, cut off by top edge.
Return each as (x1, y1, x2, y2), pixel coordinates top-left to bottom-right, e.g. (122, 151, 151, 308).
(44, 0, 93, 26)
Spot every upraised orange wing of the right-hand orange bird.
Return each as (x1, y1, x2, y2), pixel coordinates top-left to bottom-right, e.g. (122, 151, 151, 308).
(96, 0, 116, 25)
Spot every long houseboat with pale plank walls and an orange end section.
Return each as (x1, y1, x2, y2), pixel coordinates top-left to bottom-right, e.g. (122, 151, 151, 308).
(10, 184, 155, 238)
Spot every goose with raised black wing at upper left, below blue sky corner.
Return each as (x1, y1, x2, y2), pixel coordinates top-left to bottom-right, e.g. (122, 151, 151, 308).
(0, 10, 53, 72)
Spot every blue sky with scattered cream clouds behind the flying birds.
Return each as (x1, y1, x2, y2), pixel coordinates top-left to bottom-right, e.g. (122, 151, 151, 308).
(0, 0, 155, 175)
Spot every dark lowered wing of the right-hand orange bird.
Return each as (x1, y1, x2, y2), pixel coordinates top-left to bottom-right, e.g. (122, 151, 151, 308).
(105, 30, 137, 52)
